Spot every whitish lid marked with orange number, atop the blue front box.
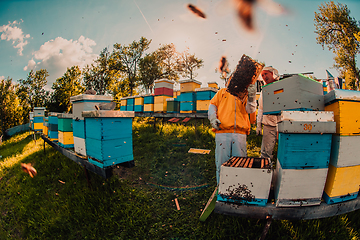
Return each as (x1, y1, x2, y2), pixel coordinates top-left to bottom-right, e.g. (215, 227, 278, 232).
(280, 111, 334, 122)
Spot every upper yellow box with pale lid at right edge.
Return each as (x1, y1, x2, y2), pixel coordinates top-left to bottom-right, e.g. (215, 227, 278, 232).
(324, 89, 360, 135)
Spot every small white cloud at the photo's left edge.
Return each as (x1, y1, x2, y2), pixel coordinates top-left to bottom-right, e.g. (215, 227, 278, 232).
(0, 20, 30, 56)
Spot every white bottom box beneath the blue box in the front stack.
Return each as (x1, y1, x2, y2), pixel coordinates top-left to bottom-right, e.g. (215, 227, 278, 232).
(274, 161, 328, 207)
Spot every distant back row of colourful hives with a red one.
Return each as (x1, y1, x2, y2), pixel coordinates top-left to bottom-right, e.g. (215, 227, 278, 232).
(120, 79, 218, 113)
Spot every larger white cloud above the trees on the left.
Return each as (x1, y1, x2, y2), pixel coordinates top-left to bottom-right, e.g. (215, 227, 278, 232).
(24, 36, 98, 86)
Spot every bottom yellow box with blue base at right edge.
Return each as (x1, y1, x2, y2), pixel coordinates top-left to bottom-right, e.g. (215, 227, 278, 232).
(323, 164, 360, 204)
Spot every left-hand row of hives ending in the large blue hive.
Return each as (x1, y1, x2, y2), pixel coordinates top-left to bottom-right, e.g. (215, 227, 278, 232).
(30, 94, 134, 168)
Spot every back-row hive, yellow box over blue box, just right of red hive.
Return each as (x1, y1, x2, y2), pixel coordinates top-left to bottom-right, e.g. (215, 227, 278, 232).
(178, 79, 201, 113)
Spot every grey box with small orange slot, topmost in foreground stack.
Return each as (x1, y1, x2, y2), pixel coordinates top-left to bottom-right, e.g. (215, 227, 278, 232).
(262, 74, 325, 114)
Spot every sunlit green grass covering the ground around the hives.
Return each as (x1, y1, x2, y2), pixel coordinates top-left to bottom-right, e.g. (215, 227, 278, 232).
(0, 121, 360, 239)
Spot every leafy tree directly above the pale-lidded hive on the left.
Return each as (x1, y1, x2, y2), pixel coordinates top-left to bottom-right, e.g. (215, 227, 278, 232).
(83, 48, 122, 95)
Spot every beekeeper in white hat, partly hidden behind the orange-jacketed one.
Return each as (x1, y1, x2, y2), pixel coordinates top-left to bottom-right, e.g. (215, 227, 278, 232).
(256, 66, 280, 159)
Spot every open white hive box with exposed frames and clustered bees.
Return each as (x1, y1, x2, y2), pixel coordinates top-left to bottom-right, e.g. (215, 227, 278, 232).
(217, 157, 272, 206)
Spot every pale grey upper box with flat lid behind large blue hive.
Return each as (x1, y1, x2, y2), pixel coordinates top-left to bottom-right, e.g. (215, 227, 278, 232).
(70, 94, 113, 120)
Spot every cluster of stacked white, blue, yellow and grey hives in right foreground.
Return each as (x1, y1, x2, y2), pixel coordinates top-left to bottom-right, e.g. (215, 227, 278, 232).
(218, 75, 360, 207)
